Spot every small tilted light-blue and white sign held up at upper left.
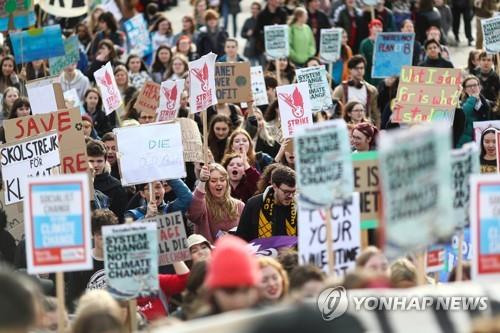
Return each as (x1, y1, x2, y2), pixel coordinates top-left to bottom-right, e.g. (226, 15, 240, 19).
(123, 14, 153, 58)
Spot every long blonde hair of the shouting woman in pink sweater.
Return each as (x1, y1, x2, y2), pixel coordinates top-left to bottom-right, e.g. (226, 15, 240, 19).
(205, 163, 240, 223)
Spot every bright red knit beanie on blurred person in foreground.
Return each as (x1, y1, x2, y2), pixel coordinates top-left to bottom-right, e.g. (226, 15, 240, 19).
(205, 235, 260, 289)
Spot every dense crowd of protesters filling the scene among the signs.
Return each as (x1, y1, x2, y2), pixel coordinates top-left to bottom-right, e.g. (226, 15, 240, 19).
(0, 0, 500, 333)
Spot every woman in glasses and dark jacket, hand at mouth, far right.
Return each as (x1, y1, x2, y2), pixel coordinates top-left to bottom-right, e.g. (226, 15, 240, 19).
(456, 75, 494, 148)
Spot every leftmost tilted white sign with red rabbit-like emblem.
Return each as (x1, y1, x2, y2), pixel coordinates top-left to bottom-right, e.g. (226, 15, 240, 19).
(94, 62, 122, 115)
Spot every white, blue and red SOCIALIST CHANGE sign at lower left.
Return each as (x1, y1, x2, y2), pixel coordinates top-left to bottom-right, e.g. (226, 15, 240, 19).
(24, 173, 92, 274)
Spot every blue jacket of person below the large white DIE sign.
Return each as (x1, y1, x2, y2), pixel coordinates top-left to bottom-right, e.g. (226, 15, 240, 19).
(124, 179, 193, 221)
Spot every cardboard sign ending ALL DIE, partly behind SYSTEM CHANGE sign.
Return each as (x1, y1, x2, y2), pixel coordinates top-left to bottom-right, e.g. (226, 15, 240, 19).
(146, 212, 191, 266)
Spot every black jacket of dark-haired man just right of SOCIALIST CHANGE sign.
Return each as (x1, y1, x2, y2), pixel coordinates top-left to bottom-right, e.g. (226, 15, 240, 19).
(94, 172, 128, 222)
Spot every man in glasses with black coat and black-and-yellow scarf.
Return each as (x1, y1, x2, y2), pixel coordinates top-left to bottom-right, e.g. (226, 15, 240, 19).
(236, 166, 297, 242)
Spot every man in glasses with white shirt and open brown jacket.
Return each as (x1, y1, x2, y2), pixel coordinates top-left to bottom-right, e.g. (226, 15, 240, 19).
(332, 55, 380, 128)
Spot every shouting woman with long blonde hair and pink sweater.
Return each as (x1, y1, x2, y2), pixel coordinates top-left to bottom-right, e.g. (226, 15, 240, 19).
(188, 163, 245, 243)
